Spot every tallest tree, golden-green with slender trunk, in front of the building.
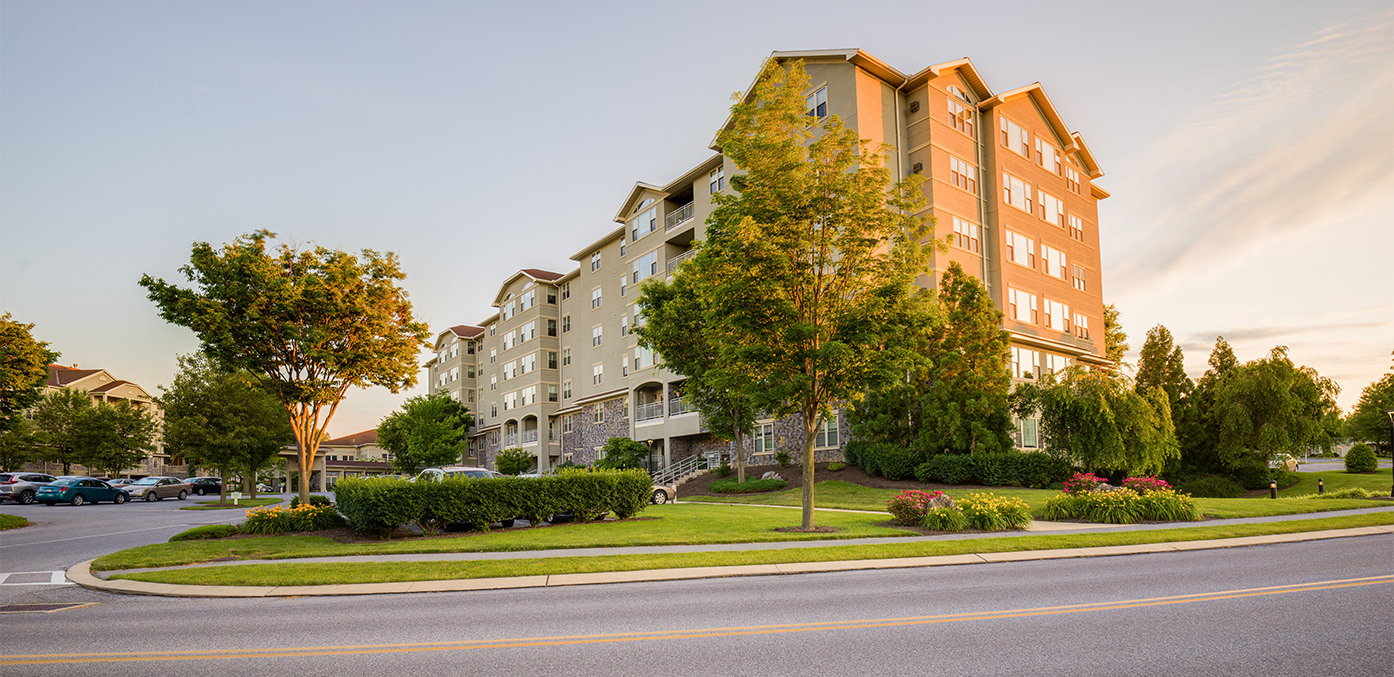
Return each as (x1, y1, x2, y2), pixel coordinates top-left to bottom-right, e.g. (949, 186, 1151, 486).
(684, 60, 927, 529)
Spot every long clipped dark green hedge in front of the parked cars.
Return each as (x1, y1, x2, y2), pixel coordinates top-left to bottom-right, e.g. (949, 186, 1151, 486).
(335, 469, 652, 535)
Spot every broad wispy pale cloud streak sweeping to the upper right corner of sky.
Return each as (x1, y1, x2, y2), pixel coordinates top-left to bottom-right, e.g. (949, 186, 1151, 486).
(1111, 14, 1394, 284)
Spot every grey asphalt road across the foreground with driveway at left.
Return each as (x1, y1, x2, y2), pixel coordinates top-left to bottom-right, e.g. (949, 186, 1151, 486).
(0, 501, 1394, 676)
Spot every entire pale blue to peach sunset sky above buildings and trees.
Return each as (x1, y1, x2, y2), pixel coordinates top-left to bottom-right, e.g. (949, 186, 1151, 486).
(0, 0, 1394, 436)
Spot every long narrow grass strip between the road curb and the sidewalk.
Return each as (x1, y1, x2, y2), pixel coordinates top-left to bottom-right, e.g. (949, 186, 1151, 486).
(103, 513, 1394, 585)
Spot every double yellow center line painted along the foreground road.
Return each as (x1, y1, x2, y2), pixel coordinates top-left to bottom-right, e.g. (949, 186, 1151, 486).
(8, 575, 1394, 666)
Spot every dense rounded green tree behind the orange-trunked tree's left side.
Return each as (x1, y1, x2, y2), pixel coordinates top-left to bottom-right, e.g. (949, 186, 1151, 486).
(159, 354, 294, 500)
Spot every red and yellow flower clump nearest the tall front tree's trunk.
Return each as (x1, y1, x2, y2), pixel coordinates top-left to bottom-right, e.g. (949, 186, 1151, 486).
(885, 489, 1032, 531)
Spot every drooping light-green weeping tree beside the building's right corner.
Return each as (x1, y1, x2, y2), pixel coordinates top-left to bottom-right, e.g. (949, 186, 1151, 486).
(1012, 366, 1181, 475)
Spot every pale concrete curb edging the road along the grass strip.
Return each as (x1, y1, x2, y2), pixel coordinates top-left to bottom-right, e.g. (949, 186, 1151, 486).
(67, 525, 1394, 598)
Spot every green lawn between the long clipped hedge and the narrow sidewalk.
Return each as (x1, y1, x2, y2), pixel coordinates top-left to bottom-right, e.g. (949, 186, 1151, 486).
(92, 504, 916, 571)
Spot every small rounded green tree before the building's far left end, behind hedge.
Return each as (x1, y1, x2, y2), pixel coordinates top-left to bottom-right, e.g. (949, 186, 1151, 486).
(378, 393, 473, 475)
